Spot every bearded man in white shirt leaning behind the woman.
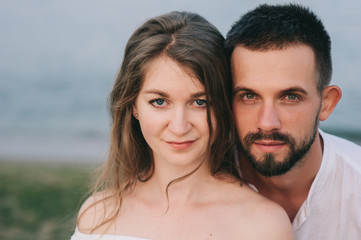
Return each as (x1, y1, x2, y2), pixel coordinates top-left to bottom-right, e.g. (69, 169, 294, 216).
(226, 4, 361, 240)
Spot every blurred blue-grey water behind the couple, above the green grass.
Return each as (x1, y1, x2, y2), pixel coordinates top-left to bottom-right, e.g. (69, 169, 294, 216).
(0, 0, 361, 161)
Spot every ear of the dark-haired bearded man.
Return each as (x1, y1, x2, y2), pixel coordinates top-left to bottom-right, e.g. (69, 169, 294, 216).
(318, 85, 342, 121)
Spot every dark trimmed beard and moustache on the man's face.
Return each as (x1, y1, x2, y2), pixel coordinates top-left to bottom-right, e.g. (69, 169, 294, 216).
(238, 120, 318, 177)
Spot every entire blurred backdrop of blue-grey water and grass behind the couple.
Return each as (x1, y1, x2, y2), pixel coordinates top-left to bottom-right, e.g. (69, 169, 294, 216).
(0, 0, 361, 239)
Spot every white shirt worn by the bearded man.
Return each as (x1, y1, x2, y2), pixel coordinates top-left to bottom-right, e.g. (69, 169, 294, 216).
(292, 131, 361, 240)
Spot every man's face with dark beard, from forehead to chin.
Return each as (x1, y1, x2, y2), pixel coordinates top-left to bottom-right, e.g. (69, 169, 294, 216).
(231, 45, 321, 177)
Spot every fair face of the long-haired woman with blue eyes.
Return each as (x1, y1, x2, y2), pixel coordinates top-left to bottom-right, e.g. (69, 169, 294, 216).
(133, 56, 216, 172)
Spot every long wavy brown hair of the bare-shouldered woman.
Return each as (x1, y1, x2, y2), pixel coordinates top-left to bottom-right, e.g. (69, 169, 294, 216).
(80, 12, 237, 232)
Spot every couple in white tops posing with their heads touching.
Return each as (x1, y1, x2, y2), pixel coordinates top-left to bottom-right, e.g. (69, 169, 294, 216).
(72, 4, 361, 240)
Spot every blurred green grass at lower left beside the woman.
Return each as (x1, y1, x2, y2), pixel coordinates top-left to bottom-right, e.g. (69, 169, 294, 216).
(0, 161, 95, 240)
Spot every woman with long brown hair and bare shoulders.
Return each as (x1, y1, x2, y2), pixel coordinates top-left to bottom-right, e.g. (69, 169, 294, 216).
(72, 12, 293, 240)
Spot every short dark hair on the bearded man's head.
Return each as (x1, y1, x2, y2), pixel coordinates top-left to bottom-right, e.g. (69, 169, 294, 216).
(225, 4, 332, 93)
